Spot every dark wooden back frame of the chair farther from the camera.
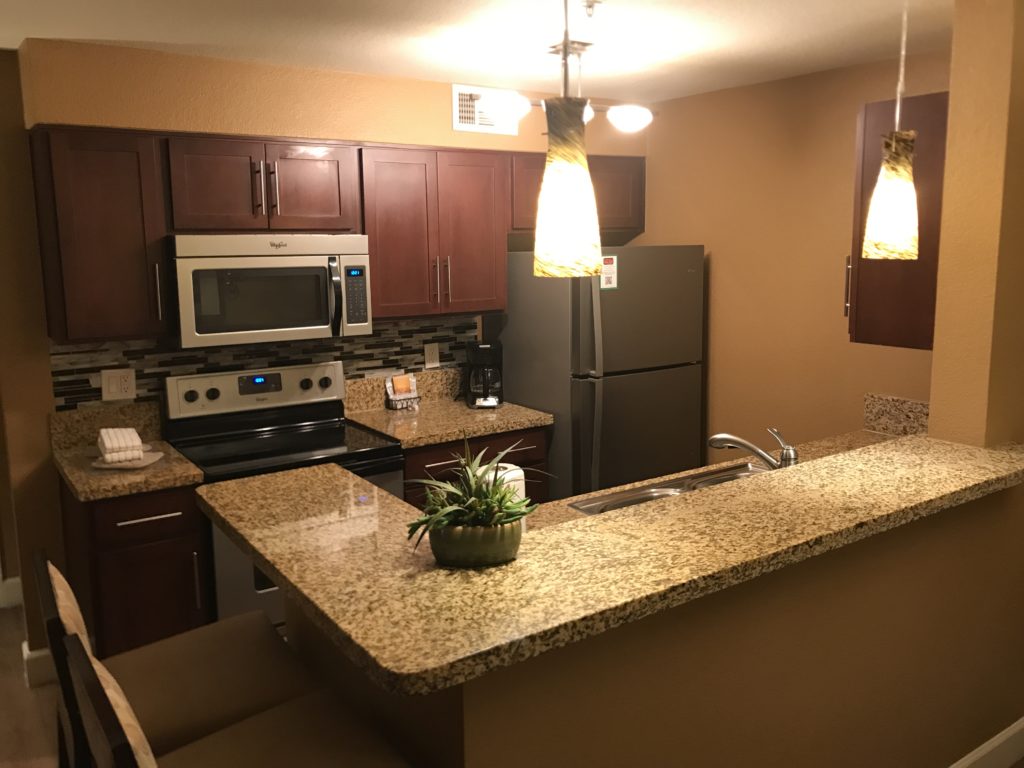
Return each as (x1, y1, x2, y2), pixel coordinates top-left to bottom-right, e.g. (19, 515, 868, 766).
(33, 552, 92, 768)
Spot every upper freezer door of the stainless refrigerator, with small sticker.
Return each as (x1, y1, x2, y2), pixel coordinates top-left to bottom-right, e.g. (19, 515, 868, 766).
(572, 246, 703, 376)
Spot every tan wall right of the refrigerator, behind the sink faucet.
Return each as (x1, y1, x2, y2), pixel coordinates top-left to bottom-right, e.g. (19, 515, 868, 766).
(641, 55, 948, 454)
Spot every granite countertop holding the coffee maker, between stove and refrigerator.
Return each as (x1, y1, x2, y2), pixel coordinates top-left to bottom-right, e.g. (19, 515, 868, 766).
(345, 399, 555, 449)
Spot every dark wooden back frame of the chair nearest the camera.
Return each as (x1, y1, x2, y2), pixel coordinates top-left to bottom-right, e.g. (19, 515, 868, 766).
(63, 635, 138, 768)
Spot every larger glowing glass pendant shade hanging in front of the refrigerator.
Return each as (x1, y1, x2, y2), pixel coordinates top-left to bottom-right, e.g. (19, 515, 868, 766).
(534, 97, 601, 278)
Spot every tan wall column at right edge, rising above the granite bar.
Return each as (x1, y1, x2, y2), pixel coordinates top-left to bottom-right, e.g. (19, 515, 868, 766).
(929, 0, 1024, 444)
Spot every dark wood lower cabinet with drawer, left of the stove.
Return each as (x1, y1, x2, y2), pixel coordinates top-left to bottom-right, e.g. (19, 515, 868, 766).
(60, 483, 216, 656)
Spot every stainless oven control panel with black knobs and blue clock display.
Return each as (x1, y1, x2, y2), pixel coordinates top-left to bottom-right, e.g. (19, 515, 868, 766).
(167, 360, 345, 419)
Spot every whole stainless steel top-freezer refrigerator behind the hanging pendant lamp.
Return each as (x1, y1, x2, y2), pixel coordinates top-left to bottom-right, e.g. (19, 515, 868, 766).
(501, 246, 705, 498)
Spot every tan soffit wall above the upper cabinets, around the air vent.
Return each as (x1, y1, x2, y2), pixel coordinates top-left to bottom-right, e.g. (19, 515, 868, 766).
(20, 40, 645, 155)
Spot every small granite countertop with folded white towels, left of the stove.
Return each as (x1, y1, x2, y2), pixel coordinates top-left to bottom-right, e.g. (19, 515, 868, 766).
(53, 440, 203, 502)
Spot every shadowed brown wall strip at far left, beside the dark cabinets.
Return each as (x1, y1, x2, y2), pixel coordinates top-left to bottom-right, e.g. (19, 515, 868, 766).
(0, 51, 63, 648)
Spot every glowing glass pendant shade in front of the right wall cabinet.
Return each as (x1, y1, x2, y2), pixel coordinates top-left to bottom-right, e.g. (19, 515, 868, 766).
(861, 131, 918, 260)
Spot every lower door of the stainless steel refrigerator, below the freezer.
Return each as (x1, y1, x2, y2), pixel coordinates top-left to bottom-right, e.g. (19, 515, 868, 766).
(572, 366, 705, 494)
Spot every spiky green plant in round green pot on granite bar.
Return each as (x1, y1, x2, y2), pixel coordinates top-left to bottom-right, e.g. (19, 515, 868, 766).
(409, 442, 537, 567)
